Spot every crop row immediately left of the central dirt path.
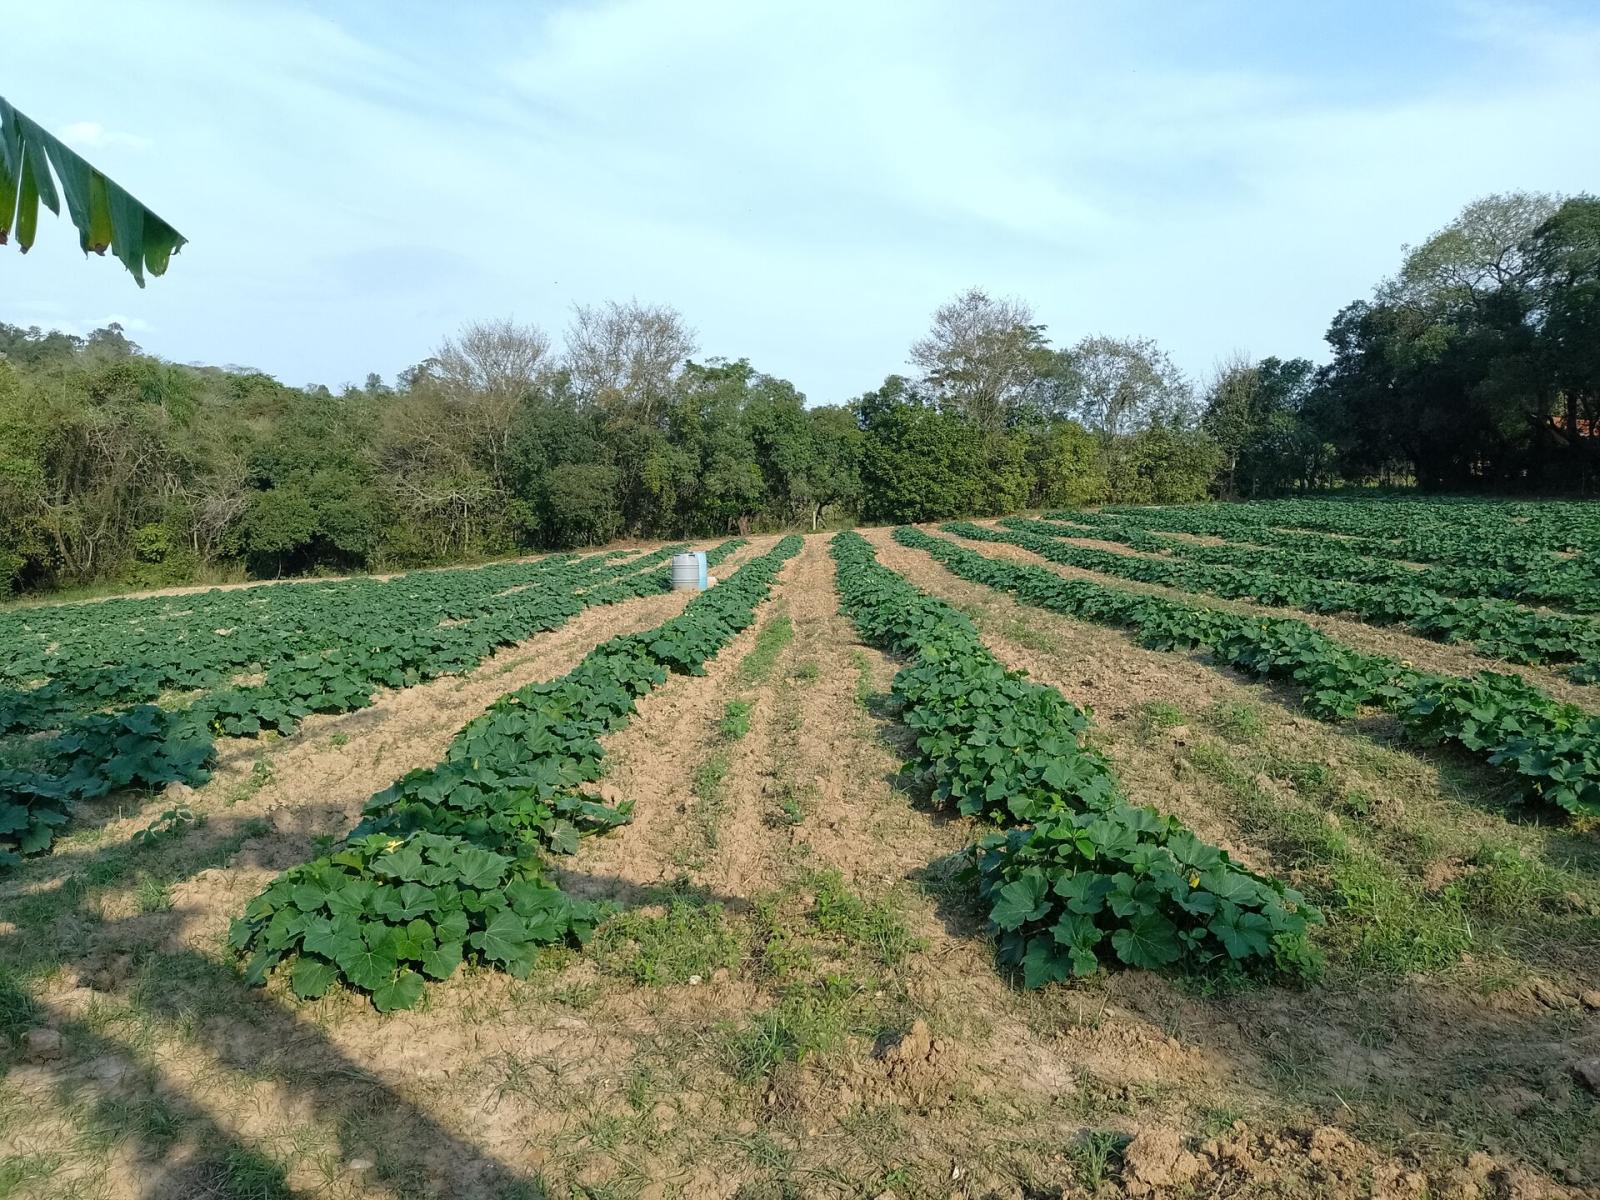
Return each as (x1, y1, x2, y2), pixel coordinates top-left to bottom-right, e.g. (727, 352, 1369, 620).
(229, 536, 802, 1010)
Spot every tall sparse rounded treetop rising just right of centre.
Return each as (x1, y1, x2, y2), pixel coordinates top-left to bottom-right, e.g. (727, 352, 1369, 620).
(910, 288, 1050, 432)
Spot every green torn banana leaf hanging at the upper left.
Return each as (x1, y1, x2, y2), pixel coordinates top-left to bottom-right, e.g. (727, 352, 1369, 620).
(0, 96, 187, 288)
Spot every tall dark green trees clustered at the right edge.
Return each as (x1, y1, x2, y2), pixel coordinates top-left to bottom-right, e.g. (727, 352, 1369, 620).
(1203, 194, 1600, 496)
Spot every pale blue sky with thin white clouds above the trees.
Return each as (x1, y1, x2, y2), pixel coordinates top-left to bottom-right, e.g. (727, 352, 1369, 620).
(0, 0, 1600, 403)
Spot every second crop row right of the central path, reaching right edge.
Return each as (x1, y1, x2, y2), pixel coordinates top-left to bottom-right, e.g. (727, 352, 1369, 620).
(894, 526, 1600, 822)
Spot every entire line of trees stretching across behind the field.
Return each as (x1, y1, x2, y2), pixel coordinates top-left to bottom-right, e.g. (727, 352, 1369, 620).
(0, 195, 1600, 594)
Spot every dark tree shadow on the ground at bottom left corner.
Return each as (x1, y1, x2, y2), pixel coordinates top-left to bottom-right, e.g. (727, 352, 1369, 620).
(0, 819, 544, 1200)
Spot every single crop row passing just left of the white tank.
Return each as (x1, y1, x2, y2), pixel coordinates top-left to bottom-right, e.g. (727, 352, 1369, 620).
(0, 539, 744, 867)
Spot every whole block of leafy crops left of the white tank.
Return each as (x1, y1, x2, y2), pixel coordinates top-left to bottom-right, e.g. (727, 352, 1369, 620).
(0, 542, 739, 866)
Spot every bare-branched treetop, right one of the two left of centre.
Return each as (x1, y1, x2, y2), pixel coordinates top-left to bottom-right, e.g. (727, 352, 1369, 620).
(565, 301, 696, 426)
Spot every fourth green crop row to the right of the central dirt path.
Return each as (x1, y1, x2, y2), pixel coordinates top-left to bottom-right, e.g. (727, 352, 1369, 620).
(1000, 514, 1600, 613)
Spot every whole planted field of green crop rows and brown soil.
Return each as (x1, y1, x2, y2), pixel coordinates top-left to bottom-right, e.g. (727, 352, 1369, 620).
(0, 501, 1600, 1200)
